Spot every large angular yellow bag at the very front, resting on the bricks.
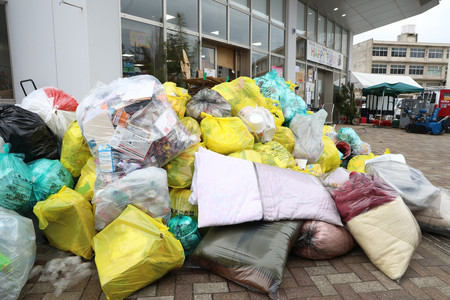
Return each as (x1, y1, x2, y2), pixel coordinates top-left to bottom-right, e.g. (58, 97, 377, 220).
(92, 205, 184, 300)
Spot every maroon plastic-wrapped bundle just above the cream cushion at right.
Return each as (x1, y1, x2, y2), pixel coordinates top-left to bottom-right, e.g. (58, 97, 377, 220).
(331, 172, 398, 222)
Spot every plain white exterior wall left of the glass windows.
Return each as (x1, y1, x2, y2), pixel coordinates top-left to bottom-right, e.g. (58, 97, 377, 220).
(7, 0, 122, 103)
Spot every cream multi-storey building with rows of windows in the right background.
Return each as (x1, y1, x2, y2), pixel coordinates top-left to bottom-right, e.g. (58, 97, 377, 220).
(352, 25, 450, 87)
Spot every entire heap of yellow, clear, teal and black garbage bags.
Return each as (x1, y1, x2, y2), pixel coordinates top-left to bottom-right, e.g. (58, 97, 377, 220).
(0, 71, 450, 299)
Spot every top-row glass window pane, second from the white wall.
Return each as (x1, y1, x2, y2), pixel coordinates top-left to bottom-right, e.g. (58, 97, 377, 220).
(166, 0, 198, 32)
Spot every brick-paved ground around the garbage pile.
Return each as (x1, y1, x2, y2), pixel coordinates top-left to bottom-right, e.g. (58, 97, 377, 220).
(21, 125, 450, 300)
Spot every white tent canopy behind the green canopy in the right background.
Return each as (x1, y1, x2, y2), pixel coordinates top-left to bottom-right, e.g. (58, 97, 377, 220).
(351, 72, 422, 89)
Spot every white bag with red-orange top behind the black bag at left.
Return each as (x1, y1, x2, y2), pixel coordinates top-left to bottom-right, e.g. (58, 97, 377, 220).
(20, 88, 78, 141)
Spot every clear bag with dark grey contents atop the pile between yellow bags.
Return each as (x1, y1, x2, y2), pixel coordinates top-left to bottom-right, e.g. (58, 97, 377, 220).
(186, 89, 231, 122)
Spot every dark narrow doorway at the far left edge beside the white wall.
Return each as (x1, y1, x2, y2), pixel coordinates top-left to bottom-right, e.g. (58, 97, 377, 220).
(0, 2, 15, 104)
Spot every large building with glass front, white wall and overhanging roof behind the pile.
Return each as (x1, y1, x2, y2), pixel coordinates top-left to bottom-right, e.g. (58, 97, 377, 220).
(0, 0, 439, 107)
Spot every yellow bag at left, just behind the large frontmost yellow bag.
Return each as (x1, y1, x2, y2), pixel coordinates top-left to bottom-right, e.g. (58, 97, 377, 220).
(33, 186, 97, 259)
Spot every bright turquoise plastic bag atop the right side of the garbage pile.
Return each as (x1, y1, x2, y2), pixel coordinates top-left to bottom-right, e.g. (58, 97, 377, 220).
(254, 70, 306, 124)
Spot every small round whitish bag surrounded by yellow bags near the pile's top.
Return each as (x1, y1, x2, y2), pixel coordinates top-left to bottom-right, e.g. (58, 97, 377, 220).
(238, 106, 276, 143)
